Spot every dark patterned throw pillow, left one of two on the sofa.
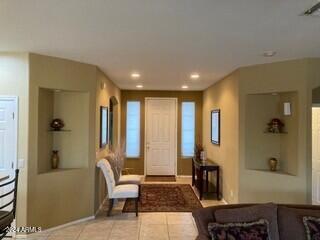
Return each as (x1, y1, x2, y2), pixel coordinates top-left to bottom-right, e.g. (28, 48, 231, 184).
(208, 219, 270, 240)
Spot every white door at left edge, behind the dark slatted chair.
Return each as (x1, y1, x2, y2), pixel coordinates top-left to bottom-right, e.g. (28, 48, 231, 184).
(0, 97, 17, 210)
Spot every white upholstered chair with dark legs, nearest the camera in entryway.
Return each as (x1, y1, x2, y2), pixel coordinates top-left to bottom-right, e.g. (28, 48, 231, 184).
(97, 159, 139, 216)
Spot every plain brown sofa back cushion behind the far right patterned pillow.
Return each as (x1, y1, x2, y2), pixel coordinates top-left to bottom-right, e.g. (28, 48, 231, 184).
(278, 206, 320, 240)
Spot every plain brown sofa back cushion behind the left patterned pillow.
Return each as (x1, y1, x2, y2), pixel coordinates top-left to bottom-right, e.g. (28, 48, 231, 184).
(215, 203, 279, 240)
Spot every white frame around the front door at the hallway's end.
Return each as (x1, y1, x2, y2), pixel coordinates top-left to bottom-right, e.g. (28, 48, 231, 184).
(144, 97, 178, 176)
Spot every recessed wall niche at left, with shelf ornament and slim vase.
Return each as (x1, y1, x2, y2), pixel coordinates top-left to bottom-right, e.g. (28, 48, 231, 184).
(38, 88, 89, 174)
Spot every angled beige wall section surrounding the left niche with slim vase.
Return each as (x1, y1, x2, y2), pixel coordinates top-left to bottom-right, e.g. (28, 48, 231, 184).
(27, 54, 96, 228)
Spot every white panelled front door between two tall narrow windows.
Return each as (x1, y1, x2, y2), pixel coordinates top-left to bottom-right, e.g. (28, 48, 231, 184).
(145, 98, 177, 175)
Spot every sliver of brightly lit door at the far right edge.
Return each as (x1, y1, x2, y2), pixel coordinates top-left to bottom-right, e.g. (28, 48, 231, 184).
(312, 106, 320, 205)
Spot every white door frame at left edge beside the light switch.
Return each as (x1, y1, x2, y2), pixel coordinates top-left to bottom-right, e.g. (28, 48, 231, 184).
(0, 95, 19, 170)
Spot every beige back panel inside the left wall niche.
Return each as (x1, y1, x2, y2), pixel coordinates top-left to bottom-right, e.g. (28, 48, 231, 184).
(52, 91, 90, 168)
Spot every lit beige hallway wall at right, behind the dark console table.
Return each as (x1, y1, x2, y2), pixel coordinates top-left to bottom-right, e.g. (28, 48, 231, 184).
(202, 71, 239, 203)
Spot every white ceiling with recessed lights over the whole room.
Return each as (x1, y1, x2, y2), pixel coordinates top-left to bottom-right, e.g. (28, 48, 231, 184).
(0, 0, 320, 90)
